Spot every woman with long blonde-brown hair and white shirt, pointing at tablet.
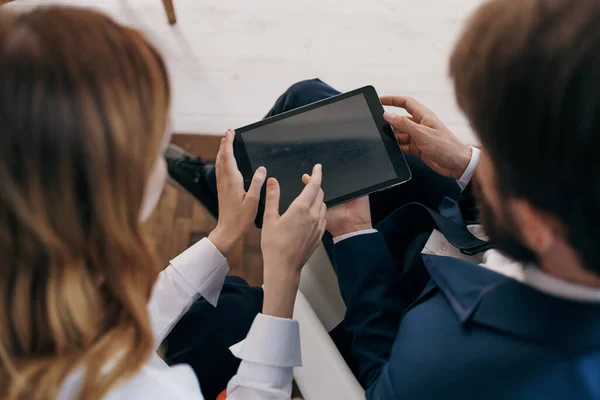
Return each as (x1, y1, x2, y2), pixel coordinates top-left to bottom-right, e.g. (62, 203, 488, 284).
(0, 7, 325, 399)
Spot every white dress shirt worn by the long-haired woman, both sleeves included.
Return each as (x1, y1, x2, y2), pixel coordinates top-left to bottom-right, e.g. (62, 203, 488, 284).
(58, 238, 302, 400)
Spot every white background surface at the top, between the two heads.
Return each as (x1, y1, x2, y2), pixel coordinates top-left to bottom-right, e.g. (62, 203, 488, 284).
(5, 0, 481, 143)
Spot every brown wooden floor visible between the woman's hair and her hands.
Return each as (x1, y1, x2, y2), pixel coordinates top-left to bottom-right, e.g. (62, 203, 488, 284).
(145, 135, 262, 286)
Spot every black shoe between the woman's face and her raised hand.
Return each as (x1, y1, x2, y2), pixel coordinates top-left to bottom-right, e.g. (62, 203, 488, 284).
(165, 144, 219, 218)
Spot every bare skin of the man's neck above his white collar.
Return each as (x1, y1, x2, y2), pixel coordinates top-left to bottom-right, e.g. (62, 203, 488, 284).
(539, 243, 600, 289)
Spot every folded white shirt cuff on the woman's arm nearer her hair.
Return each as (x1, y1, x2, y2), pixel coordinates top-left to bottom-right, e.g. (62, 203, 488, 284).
(171, 238, 229, 307)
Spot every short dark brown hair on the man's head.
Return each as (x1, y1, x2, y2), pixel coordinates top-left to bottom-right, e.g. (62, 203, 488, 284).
(450, 0, 600, 275)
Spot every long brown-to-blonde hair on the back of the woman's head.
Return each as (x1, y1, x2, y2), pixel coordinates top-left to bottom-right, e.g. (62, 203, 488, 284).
(0, 7, 169, 399)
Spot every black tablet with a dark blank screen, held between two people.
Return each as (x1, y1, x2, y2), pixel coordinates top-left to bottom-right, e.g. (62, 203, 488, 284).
(234, 86, 411, 227)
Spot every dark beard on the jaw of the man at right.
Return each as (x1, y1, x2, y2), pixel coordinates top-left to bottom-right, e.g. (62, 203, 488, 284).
(473, 185, 538, 264)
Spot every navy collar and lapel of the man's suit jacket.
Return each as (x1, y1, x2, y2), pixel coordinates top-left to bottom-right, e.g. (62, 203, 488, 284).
(423, 255, 600, 351)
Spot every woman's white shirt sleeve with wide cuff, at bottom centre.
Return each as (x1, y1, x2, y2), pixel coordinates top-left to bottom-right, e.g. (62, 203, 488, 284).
(227, 314, 302, 400)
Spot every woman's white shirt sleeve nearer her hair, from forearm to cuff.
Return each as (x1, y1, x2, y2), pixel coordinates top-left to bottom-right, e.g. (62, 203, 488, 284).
(148, 238, 229, 347)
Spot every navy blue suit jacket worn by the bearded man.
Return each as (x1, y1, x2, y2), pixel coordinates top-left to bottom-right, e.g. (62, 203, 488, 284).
(333, 205, 600, 400)
